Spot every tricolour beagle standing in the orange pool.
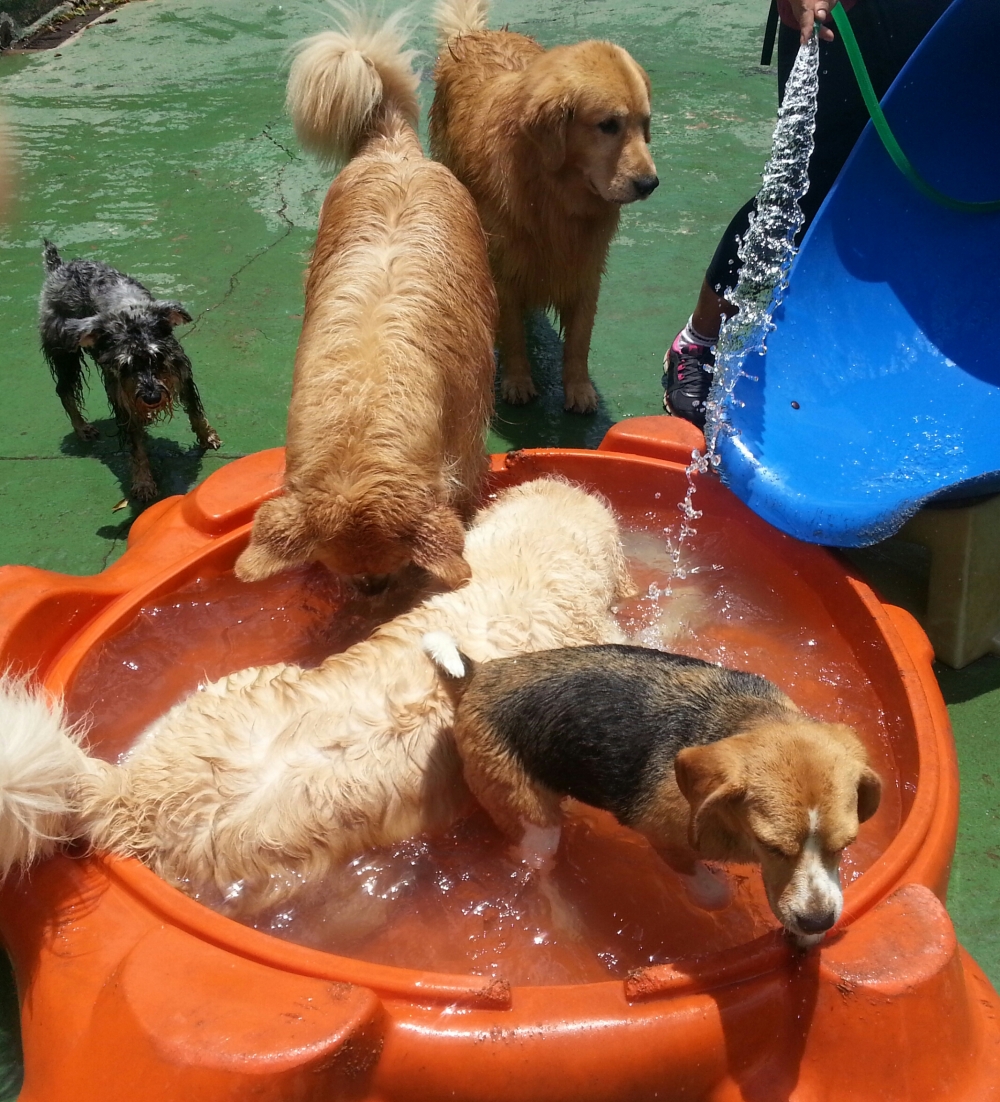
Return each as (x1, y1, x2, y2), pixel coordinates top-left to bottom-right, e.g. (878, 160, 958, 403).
(439, 644, 881, 943)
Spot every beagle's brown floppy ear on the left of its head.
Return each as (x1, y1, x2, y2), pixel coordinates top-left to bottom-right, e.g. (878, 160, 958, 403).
(674, 744, 746, 860)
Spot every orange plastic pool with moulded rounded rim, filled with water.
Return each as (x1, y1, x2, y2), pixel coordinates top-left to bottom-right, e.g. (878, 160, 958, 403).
(0, 418, 1000, 1102)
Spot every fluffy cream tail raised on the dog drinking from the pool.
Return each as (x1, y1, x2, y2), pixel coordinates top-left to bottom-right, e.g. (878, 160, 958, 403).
(286, 8, 420, 162)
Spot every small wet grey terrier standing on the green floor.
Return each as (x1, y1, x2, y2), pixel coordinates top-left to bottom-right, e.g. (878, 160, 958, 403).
(39, 241, 222, 501)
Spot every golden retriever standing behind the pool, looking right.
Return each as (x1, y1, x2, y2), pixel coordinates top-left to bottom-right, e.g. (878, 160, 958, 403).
(430, 0, 658, 413)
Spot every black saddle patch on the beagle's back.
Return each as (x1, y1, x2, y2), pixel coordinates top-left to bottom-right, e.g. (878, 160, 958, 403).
(462, 645, 786, 823)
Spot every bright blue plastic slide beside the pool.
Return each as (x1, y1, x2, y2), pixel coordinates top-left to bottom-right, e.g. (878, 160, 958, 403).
(720, 0, 1000, 547)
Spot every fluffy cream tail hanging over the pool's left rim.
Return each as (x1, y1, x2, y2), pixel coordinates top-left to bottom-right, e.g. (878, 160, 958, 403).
(0, 678, 89, 880)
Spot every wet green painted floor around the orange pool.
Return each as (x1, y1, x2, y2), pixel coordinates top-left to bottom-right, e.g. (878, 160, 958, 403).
(0, 0, 1000, 1100)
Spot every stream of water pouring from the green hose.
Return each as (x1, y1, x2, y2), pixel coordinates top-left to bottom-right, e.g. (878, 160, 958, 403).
(668, 34, 819, 579)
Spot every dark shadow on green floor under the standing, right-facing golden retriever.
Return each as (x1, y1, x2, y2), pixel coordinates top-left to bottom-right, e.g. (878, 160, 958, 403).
(492, 312, 614, 450)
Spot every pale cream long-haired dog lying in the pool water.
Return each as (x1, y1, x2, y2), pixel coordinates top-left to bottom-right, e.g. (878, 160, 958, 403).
(0, 478, 632, 915)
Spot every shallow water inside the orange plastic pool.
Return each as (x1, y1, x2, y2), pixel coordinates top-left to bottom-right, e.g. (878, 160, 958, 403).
(68, 495, 900, 984)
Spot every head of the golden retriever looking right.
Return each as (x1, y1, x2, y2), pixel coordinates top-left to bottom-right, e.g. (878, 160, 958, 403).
(524, 42, 659, 204)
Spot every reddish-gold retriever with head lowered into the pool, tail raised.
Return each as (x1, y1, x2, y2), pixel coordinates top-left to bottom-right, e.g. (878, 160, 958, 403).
(236, 15, 496, 586)
